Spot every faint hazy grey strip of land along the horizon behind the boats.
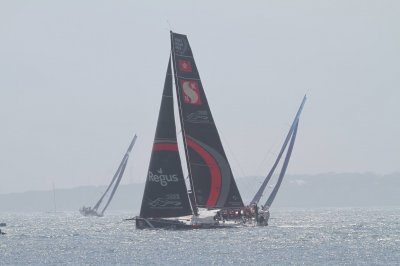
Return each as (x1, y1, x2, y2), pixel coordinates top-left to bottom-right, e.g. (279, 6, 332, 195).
(0, 173, 400, 212)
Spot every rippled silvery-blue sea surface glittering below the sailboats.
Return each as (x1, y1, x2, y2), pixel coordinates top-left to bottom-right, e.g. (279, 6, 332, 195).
(0, 208, 400, 265)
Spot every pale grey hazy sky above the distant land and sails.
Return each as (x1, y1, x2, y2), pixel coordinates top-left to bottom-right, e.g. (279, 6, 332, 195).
(0, 0, 400, 193)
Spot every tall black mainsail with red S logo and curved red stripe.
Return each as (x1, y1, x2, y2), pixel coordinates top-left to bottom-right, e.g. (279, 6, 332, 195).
(171, 32, 243, 208)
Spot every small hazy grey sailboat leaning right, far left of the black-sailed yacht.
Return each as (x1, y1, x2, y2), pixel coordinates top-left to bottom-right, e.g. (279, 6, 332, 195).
(79, 135, 137, 216)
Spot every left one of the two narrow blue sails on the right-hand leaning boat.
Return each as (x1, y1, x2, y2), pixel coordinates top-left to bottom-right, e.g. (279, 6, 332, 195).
(250, 95, 307, 205)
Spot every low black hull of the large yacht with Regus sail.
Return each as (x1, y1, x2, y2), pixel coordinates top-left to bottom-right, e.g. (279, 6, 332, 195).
(134, 217, 237, 230)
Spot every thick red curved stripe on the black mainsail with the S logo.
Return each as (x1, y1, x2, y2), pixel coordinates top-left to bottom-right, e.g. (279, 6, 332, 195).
(186, 138, 222, 207)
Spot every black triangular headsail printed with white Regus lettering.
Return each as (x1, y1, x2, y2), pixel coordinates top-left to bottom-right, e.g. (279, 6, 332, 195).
(140, 60, 192, 218)
